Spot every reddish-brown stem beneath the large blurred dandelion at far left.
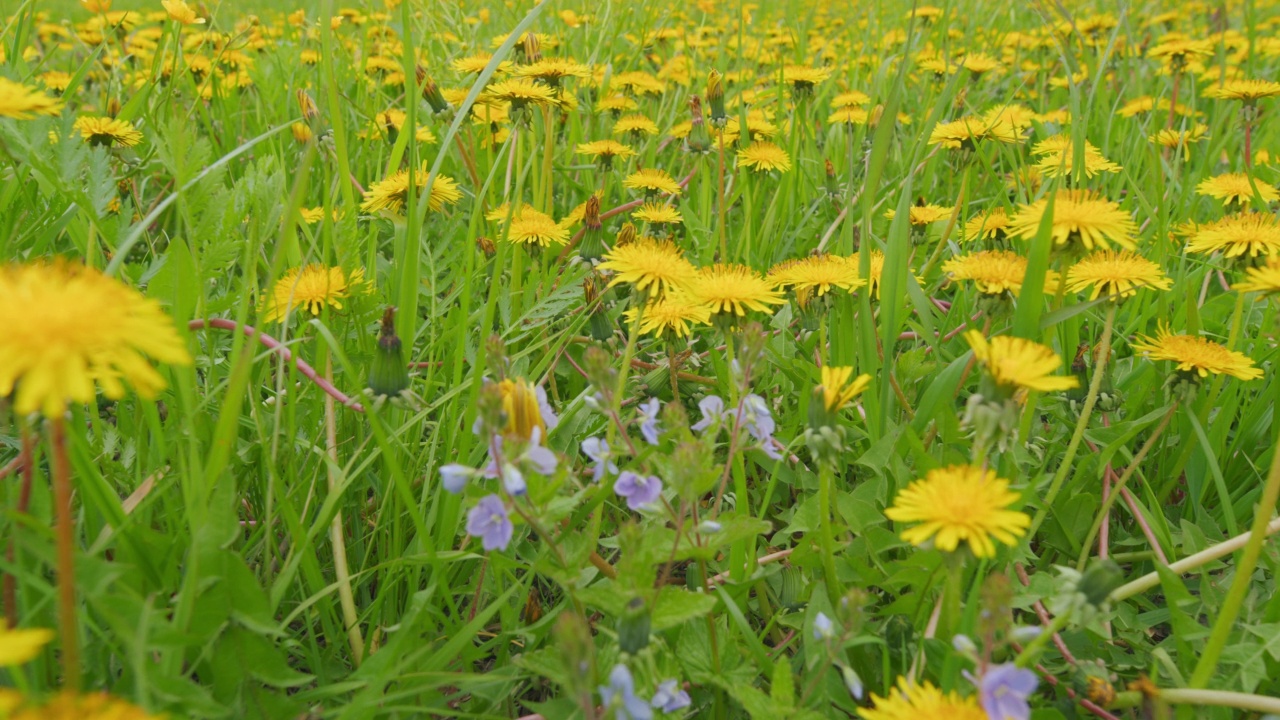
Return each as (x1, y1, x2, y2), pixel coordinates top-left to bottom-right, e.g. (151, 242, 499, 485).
(49, 415, 81, 692)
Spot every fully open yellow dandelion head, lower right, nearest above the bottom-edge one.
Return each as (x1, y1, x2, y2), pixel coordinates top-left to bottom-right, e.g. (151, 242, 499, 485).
(884, 465, 1032, 557)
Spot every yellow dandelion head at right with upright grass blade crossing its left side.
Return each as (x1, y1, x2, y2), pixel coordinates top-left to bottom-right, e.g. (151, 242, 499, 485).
(1009, 190, 1138, 250)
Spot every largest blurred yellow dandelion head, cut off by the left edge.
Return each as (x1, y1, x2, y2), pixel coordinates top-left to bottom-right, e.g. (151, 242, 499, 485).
(0, 261, 191, 416)
